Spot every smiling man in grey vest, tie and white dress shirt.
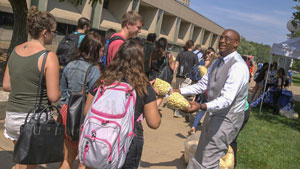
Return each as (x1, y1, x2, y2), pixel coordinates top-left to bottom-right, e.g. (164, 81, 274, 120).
(174, 29, 249, 169)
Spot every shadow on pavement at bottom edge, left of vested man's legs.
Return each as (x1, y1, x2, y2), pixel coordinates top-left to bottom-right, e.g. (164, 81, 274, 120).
(140, 155, 186, 169)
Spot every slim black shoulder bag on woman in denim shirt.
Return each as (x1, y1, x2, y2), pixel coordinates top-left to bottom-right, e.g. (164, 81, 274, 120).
(66, 65, 93, 141)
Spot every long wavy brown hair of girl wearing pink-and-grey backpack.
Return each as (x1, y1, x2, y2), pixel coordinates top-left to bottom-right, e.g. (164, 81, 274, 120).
(97, 39, 149, 96)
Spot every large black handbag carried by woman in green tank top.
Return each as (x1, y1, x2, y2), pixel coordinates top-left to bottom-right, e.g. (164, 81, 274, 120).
(13, 51, 65, 165)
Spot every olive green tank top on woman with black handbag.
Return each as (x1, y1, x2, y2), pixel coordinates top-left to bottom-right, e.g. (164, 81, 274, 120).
(6, 50, 48, 113)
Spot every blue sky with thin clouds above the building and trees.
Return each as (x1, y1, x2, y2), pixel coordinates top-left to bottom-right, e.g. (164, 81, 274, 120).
(190, 0, 297, 45)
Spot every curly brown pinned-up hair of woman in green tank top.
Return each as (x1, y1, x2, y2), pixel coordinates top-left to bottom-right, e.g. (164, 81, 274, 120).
(26, 6, 56, 39)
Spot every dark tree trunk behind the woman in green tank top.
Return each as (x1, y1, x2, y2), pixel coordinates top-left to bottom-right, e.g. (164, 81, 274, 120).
(5, 0, 28, 65)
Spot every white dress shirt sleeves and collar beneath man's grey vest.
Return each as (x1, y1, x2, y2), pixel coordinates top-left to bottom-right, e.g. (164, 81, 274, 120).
(180, 51, 249, 112)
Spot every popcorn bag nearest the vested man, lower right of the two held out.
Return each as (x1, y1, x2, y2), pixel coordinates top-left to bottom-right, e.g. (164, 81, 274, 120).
(167, 92, 190, 110)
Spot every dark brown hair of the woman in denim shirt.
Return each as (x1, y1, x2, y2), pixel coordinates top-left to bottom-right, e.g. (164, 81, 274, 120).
(73, 31, 105, 65)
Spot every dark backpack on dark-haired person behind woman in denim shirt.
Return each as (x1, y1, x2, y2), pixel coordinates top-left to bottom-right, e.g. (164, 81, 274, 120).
(56, 32, 84, 66)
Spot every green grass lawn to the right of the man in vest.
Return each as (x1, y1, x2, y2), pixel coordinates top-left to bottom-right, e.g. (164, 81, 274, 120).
(237, 102, 300, 169)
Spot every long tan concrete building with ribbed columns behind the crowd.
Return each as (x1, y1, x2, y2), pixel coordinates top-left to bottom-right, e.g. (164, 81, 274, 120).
(0, 0, 224, 51)
